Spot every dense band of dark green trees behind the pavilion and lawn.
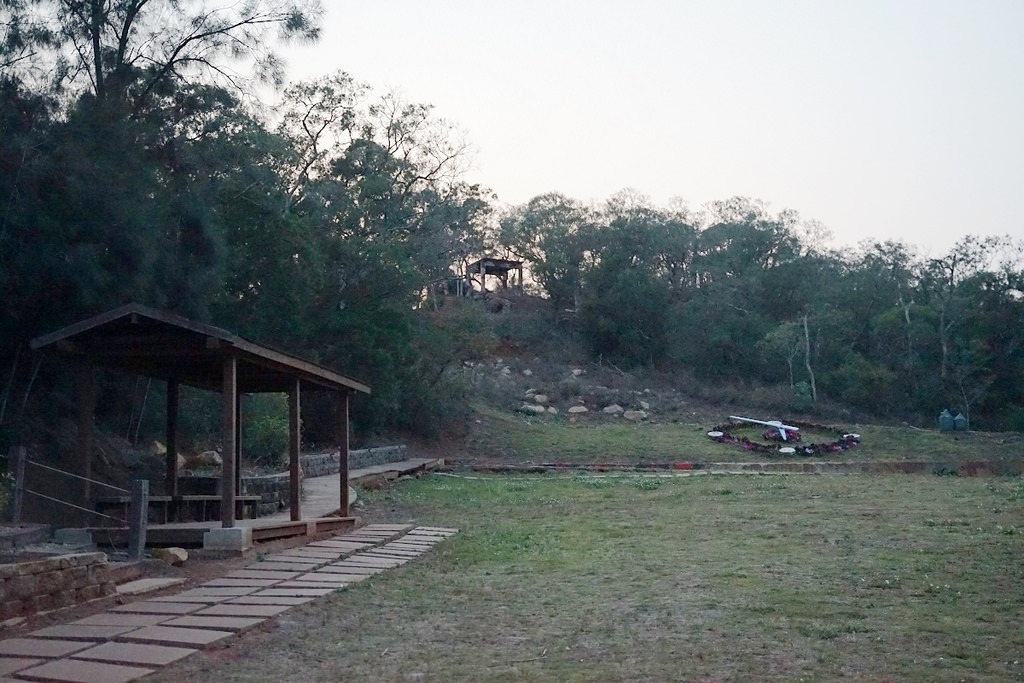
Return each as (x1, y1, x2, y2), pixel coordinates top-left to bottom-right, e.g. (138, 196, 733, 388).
(0, 0, 1024, 448)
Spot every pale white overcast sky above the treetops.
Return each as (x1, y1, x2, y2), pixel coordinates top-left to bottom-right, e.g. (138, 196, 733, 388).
(276, 0, 1024, 254)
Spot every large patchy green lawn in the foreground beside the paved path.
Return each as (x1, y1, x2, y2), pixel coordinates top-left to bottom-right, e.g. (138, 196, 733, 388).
(155, 475, 1024, 681)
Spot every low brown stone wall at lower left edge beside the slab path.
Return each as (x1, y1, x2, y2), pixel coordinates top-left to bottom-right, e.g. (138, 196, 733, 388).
(0, 553, 116, 620)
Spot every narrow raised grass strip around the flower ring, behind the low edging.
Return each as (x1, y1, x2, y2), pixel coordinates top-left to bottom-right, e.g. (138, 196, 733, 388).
(467, 408, 1024, 464)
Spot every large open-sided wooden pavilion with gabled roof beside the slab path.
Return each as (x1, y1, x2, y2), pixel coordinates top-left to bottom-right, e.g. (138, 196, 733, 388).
(31, 303, 370, 528)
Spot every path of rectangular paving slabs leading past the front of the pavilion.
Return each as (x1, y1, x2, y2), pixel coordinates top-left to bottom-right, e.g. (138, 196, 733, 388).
(0, 524, 458, 683)
